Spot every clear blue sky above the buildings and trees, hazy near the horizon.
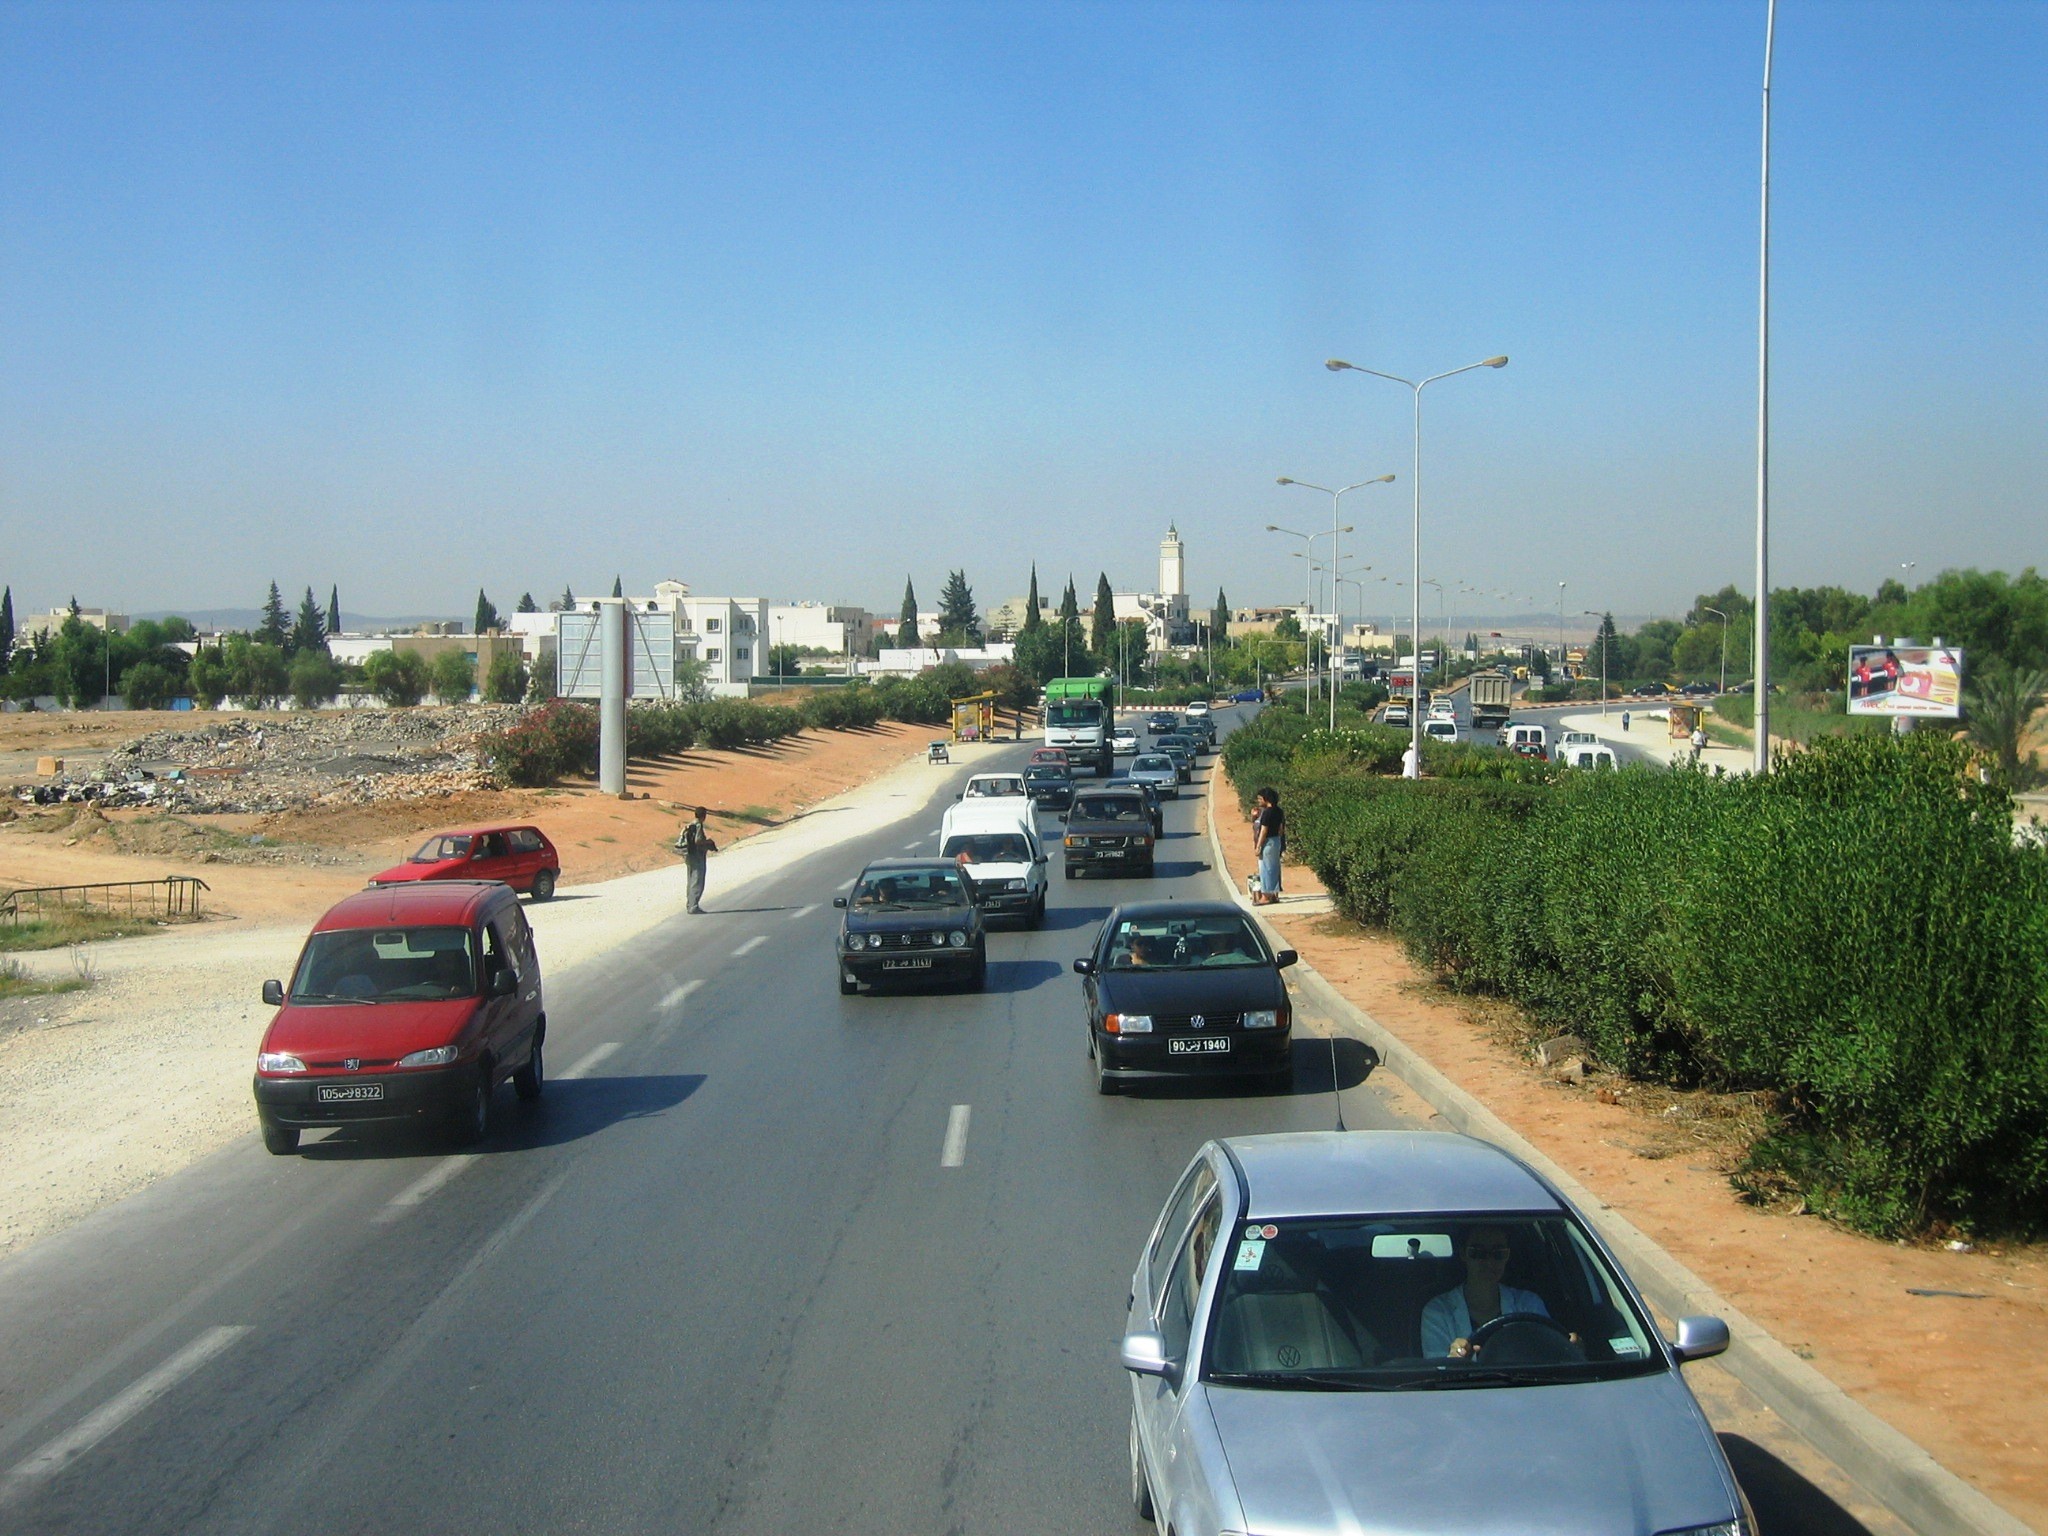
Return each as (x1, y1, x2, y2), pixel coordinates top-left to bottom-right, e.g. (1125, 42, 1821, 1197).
(0, 0, 2048, 614)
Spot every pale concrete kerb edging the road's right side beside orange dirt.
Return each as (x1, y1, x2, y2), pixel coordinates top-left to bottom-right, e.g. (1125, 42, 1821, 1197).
(1204, 762, 2036, 1536)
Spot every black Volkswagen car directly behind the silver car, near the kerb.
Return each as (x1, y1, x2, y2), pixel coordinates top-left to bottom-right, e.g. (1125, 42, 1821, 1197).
(1073, 901, 1294, 1094)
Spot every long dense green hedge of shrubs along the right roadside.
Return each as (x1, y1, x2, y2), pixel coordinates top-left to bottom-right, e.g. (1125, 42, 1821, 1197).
(1225, 717, 2048, 1233)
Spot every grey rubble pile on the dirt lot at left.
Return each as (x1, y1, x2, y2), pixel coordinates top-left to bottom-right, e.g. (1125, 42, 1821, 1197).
(14, 705, 524, 815)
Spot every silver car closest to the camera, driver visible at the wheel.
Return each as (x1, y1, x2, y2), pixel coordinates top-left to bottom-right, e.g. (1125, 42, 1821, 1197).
(1122, 1130, 1755, 1536)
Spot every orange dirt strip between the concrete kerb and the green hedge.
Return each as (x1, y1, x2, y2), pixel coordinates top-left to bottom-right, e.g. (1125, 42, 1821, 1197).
(1212, 766, 2048, 1530)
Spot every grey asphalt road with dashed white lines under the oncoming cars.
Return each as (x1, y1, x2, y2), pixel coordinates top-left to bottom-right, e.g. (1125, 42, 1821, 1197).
(0, 712, 1900, 1536)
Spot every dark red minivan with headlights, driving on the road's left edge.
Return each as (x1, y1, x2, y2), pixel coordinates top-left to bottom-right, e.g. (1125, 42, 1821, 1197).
(256, 881, 547, 1155)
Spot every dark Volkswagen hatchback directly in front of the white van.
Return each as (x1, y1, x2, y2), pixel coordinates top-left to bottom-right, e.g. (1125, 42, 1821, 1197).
(831, 858, 989, 993)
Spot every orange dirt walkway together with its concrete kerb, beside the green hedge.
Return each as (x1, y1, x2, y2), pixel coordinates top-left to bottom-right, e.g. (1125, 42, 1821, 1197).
(1210, 765, 2048, 1532)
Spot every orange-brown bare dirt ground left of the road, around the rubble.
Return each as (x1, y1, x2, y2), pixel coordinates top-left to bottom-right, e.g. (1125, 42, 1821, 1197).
(0, 711, 932, 922)
